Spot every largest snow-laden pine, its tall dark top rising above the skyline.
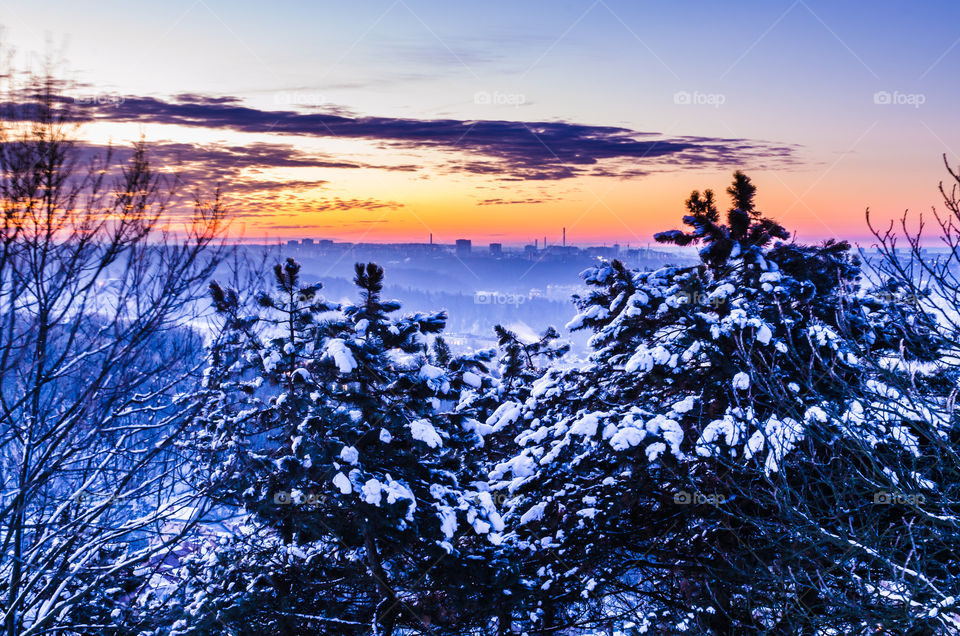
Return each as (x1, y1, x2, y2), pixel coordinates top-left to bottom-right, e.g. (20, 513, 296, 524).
(490, 173, 956, 633)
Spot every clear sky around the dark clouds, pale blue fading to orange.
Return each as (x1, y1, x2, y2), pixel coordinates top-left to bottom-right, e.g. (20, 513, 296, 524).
(0, 0, 960, 241)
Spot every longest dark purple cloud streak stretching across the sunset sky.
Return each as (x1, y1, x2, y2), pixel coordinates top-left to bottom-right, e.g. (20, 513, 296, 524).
(47, 94, 796, 180)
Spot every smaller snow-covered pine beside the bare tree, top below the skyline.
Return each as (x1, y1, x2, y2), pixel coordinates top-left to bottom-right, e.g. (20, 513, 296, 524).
(187, 260, 510, 634)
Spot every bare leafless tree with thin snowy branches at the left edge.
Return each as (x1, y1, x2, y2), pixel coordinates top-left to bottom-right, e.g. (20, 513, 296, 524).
(0, 63, 224, 636)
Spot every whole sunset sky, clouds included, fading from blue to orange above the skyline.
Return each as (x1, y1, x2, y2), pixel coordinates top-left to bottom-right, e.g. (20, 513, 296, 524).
(0, 0, 960, 246)
